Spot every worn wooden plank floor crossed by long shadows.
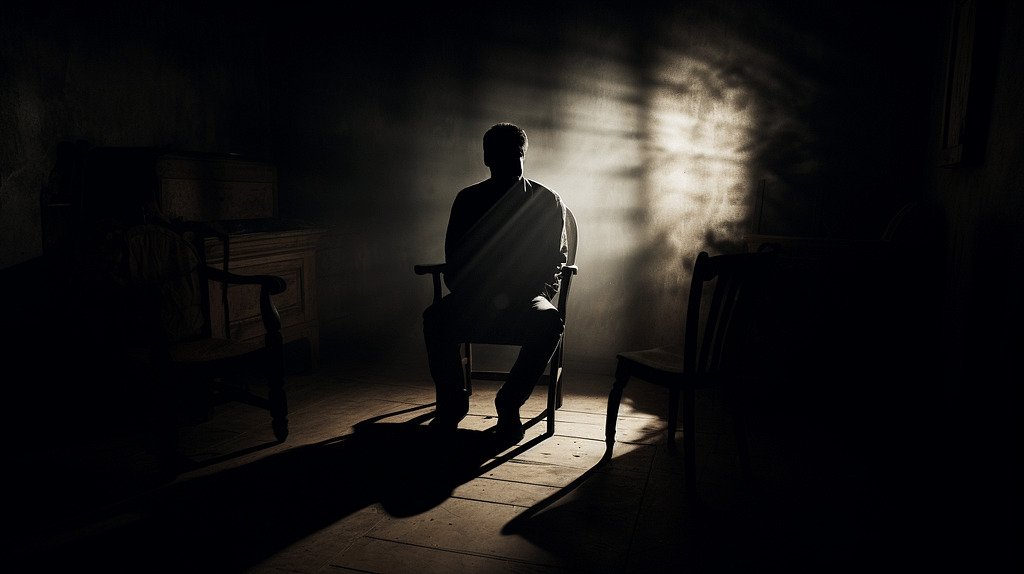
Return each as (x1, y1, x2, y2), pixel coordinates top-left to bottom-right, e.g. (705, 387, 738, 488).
(9, 341, 950, 574)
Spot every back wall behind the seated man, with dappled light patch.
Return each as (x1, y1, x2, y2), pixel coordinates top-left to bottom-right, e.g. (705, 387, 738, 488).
(271, 2, 937, 359)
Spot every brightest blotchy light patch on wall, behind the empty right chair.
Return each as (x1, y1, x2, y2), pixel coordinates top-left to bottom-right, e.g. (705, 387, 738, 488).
(625, 50, 752, 347)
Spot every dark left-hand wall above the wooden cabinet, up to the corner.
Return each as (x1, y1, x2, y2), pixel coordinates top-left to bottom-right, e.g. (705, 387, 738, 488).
(0, 2, 270, 268)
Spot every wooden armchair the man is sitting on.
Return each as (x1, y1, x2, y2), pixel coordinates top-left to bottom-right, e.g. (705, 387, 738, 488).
(414, 208, 580, 435)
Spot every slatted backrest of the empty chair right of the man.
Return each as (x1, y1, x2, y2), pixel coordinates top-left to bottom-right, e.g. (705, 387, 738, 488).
(684, 252, 777, 376)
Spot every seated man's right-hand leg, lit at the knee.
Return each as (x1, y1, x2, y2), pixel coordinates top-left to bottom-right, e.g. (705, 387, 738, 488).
(495, 297, 564, 432)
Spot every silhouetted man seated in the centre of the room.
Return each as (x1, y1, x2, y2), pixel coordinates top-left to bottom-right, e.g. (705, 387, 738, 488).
(423, 124, 567, 440)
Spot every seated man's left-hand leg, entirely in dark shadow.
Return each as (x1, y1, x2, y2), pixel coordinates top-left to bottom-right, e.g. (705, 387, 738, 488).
(423, 297, 469, 428)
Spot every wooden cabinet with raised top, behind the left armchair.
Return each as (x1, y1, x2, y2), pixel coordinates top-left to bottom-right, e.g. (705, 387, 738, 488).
(72, 147, 325, 365)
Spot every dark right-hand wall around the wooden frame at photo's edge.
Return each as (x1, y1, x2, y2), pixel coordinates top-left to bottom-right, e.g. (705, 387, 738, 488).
(921, 2, 1024, 556)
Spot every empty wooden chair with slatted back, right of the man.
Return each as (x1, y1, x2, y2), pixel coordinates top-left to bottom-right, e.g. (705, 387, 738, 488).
(605, 252, 776, 496)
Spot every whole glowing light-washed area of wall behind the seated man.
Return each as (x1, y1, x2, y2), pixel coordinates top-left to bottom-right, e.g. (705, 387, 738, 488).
(405, 24, 757, 368)
